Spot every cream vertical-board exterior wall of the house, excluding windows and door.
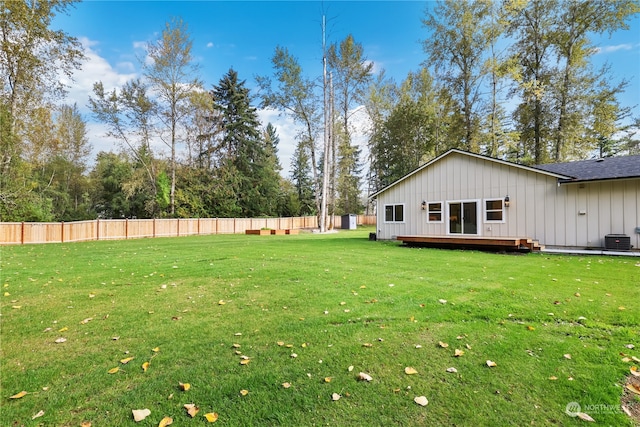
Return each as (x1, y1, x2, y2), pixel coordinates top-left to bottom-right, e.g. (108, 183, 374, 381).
(377, 152, 640, 248)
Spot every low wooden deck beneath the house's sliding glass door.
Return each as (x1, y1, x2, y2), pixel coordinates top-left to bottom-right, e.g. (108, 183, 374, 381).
(396, 235, 544, 252)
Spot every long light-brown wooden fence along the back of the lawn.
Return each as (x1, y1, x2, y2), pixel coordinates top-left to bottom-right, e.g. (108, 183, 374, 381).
(0, 215, 376, 245)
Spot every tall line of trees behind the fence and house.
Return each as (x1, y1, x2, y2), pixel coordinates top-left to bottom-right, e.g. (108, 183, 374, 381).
(0, 0, 640, 221)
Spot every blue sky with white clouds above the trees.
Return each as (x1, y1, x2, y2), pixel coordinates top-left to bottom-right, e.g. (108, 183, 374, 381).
(52, 1, 640, 175)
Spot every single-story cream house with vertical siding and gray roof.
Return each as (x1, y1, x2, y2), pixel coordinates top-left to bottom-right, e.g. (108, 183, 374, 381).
(372, 149, 640, 249)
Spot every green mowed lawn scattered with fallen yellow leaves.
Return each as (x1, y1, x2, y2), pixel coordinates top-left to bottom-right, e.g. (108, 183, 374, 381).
(0, 228, 640, 426)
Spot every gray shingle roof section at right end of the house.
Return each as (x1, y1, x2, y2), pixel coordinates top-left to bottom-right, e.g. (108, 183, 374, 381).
(534, 155, 640, 181)
